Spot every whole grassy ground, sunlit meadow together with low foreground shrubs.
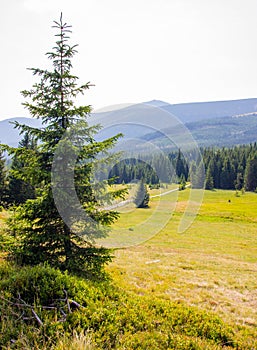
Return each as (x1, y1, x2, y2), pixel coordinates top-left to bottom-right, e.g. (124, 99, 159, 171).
(0, 187, 257, 350)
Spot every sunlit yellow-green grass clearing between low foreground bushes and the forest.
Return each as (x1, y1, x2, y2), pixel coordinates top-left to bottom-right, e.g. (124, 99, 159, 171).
(108, 190, 257, 344)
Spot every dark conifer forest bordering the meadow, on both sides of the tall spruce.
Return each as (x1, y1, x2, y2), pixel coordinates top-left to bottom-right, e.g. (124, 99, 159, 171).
(0, 143, 257, 209)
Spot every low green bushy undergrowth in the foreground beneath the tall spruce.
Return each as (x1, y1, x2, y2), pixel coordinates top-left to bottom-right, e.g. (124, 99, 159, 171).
(0, 264, 240, 350)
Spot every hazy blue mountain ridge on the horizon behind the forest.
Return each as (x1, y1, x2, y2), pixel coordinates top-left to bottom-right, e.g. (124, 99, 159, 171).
(0, 98, 257, 147)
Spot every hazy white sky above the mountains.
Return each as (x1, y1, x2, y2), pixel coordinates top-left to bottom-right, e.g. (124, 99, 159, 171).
(0, 0, 257, 119)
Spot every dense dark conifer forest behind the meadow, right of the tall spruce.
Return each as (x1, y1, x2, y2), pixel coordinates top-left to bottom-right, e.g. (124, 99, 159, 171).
(103, 143, 257, 191)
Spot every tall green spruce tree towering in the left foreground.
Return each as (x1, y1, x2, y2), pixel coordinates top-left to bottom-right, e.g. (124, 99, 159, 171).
(3, 15, 122, 275)
